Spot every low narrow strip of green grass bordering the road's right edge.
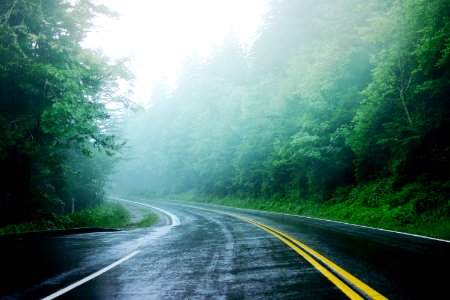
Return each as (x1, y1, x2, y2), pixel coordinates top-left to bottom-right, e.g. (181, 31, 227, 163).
(156, 190, 450, 240)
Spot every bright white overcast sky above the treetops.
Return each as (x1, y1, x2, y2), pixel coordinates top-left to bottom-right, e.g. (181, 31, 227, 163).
(84, 0, 268, 105)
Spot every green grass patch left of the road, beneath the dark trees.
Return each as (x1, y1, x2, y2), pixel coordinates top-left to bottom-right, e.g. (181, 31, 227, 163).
(0, 202, 158, 235)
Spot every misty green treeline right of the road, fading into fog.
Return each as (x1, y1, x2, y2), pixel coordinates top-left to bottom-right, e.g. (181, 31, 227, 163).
(115, 0, 450, 223)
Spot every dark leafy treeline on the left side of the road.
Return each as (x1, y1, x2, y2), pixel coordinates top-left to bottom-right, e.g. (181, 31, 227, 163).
(0, 0, 126, 225)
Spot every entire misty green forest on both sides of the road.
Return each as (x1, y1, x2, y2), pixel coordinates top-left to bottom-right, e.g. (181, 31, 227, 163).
(0, 0, 450, 239)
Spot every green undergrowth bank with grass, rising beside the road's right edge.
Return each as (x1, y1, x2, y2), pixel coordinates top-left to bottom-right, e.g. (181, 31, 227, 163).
(159, 179, 450, 240)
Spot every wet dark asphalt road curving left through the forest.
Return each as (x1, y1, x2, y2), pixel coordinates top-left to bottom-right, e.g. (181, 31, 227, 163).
(0, 200, 450, 299)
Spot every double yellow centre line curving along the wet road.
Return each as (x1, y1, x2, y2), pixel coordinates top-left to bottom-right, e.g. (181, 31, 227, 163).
(192, 206, 387, 300)
